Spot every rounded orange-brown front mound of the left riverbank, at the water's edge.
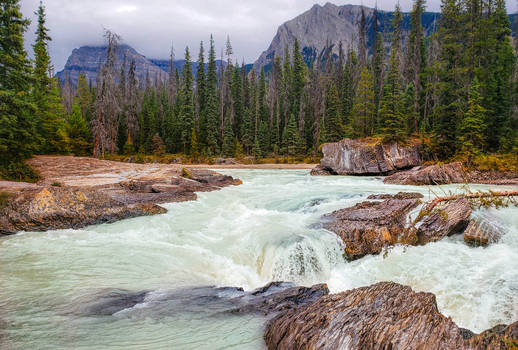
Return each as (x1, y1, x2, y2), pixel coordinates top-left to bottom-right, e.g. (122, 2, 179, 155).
(0, 187, 166, 234)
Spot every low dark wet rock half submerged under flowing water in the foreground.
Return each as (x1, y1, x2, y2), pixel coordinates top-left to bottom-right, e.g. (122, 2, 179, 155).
(73, 282, 329, 317)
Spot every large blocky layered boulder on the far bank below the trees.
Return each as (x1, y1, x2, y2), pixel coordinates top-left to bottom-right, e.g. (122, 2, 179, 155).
(320, 139, 421, 175)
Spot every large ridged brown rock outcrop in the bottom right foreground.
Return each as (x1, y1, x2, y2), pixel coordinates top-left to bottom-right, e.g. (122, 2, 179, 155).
(264, 282, 518, 350)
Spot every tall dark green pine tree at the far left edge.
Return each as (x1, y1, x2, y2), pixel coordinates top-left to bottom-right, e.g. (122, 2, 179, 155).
(0, 0, 36, 180)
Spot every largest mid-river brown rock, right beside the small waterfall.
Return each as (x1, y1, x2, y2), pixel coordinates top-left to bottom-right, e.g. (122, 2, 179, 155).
(324, 199, 421, 259)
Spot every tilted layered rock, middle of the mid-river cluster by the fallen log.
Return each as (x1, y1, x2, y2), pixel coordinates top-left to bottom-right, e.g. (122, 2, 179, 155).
(415, 197, 471, 244)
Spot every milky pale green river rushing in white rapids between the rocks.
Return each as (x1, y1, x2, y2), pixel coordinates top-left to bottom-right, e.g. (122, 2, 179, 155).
(0, 170, 518, 350)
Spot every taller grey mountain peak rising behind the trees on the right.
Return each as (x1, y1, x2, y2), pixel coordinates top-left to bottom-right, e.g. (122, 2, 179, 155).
(254, 3, 439, 69)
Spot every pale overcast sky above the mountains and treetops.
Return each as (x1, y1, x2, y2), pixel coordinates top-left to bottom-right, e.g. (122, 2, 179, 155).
(21, 0, 514, 71)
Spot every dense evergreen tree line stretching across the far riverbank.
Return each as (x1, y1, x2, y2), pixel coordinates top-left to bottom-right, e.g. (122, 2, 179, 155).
(0, 0, 518, 178)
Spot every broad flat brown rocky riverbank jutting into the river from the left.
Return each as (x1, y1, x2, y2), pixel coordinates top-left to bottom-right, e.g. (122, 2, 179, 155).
(0, 156, 241, 235)
